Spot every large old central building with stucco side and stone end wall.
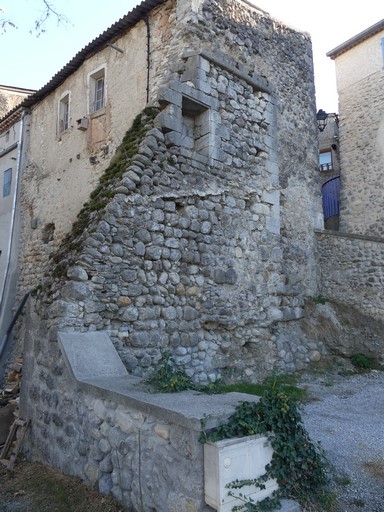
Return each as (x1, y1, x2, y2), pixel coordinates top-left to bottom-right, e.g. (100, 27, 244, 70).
(3, 3, 322, 381)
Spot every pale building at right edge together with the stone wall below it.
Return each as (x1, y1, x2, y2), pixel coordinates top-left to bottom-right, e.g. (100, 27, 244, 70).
(317, 20, 384, 360)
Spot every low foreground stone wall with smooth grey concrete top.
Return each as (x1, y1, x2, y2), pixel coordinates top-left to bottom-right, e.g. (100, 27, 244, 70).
(20, 329, 257, 512)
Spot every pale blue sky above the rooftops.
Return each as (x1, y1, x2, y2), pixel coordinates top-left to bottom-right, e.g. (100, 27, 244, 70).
(0, 0, 384, 112)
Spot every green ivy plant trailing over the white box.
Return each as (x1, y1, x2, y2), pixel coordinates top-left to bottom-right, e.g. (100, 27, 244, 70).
(201, 386, 330, 512)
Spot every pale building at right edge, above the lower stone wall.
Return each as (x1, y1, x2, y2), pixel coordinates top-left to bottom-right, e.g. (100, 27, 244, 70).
(327, 20, 384, 238)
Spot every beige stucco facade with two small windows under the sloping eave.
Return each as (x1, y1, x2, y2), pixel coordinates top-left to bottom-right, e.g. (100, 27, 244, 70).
(23, 22, 147, 238)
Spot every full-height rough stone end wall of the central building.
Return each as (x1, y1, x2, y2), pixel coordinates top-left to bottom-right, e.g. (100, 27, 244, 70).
(18, 2, 322, 382)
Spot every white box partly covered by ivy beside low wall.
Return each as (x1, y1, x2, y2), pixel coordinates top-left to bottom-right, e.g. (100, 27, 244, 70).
(204, 435, 278, 512)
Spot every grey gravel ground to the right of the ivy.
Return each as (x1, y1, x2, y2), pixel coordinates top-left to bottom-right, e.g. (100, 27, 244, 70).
(302, 370, 384, 512)
